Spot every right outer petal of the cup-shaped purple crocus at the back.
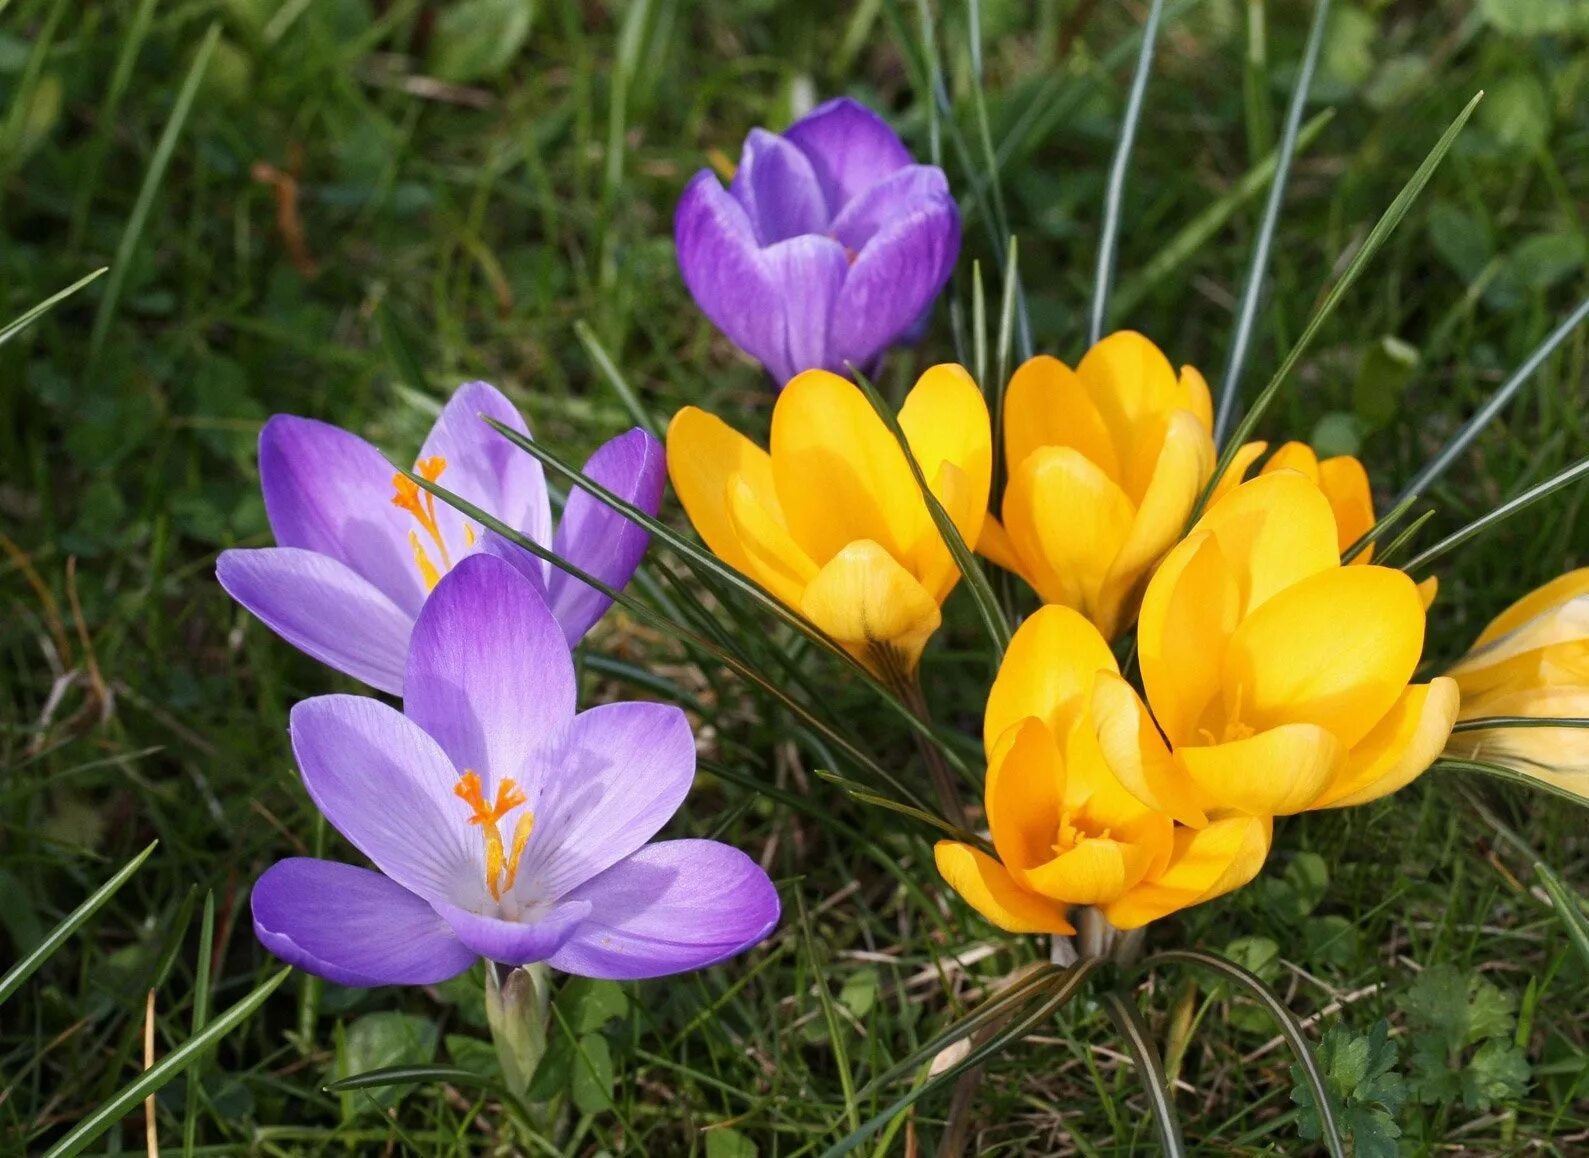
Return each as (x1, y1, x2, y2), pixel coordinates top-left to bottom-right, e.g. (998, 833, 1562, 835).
(828, 197, 960, 373)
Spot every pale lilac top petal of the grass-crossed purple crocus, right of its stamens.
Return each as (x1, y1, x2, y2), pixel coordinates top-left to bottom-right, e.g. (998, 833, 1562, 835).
(419, 381, 551, 567)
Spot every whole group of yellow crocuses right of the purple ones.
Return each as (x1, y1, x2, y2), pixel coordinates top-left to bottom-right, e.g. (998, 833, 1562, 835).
(667, 332, 1589, 932)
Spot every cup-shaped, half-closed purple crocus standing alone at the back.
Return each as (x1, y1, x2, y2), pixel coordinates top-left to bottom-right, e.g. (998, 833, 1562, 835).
(674, 97, 960, 388)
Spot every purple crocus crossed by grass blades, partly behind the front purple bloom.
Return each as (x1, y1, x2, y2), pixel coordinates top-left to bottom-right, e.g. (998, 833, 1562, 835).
(216, 381, 663, 694)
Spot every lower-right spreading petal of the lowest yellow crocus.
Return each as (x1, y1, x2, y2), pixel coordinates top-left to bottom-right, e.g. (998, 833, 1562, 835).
(1103, 816, 1273, 929)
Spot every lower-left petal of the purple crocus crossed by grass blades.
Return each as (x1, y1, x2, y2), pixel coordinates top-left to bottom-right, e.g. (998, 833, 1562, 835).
(215, 546, 413, 696)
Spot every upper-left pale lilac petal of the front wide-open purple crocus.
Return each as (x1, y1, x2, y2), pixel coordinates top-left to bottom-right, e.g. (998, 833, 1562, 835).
(289, 696, 485, 904)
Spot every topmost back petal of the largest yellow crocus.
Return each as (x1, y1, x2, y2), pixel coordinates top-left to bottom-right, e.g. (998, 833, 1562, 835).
(1195, 470, 1341, 615)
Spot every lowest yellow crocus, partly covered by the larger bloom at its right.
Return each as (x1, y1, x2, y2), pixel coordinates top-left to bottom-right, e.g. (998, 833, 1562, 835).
(934, 605, 1271, 932)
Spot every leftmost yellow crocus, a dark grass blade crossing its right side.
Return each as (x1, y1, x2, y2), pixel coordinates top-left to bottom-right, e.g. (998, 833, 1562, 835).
(667, 365, 993, 678)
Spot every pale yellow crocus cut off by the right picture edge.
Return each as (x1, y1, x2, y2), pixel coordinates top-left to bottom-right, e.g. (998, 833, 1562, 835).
(1446, 567, 1589, 801)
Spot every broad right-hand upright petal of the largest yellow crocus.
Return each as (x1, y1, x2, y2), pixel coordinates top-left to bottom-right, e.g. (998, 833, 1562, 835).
(1222, 567, 1424, 747)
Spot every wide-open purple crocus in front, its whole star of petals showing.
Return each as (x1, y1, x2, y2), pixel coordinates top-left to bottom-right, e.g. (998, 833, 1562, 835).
(253, 554, 779, 986)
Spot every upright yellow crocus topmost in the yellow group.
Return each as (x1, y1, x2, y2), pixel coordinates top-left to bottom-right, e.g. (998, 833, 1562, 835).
(977, 330, 1214, 639)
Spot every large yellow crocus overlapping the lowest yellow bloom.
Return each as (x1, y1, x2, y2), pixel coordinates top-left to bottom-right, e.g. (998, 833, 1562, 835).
(1092, 470, 1457, 826)
